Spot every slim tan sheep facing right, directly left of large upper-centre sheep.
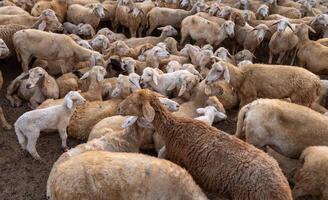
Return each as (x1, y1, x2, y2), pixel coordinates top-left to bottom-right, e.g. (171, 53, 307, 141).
(124, 25, 178, 48)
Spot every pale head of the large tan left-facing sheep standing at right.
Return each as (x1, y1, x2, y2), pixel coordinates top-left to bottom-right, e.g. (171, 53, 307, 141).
(205, 62, 230, 84)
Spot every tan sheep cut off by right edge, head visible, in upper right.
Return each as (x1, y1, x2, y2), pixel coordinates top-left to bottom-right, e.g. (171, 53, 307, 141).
(295, 24, 328, 74)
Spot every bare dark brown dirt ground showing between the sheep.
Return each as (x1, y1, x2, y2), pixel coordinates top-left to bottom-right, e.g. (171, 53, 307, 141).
(0, 55, 237, 200)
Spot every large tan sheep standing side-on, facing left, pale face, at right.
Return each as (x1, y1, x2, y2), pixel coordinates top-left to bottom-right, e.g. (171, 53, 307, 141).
(206, 61, 326, 113)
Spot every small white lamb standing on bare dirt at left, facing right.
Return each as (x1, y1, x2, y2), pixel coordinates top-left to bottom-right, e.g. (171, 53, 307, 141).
(14, 91, 86, 161)
